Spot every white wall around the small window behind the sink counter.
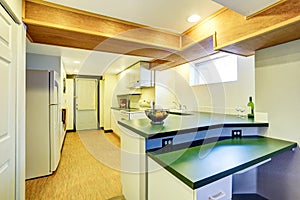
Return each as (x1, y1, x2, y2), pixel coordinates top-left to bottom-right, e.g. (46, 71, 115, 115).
(156, 56, 255, 113)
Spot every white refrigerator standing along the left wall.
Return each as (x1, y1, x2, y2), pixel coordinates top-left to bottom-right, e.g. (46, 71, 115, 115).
(26, 70, 61, 179)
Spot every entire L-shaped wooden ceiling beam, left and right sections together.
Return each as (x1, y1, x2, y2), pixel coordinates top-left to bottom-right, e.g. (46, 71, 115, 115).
(23, 0, 300, 70)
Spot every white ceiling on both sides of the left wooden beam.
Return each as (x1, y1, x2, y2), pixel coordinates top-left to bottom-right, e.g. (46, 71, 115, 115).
(27, 0, 222, 75)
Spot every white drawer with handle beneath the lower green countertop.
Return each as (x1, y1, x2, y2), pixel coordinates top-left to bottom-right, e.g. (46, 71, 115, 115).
(196, 175, 232, 200)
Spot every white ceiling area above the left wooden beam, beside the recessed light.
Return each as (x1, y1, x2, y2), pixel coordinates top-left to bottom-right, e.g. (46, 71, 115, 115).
(47, 0, 222, 33)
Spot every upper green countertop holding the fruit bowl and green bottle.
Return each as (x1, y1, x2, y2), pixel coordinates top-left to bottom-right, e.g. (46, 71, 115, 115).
(118, 112, 268, 138)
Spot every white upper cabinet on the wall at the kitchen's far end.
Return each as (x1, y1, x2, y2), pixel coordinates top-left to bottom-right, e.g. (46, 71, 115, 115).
(128, 61, 155, 88)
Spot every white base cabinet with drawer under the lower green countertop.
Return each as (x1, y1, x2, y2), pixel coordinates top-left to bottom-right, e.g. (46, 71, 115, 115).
(147, 157, 232, 200)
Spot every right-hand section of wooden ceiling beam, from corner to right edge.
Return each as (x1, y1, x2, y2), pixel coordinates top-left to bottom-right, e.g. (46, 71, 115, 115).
(182, 0, 300, 56)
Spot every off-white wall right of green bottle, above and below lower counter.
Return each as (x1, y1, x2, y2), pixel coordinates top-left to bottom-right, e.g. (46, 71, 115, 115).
(255, 40, 300, 200)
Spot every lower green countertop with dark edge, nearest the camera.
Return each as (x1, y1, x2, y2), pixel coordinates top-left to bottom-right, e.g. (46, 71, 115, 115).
(147, 136, 297, 189)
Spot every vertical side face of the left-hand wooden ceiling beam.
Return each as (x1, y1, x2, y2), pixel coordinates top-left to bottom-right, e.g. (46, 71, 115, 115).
(23, 0, 180, 50)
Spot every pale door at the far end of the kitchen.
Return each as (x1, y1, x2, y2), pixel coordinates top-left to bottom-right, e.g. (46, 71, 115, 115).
(75, 78, 98, 131)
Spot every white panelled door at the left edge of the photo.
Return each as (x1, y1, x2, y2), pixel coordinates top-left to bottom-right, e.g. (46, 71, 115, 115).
(0, 6, 17, 199)
